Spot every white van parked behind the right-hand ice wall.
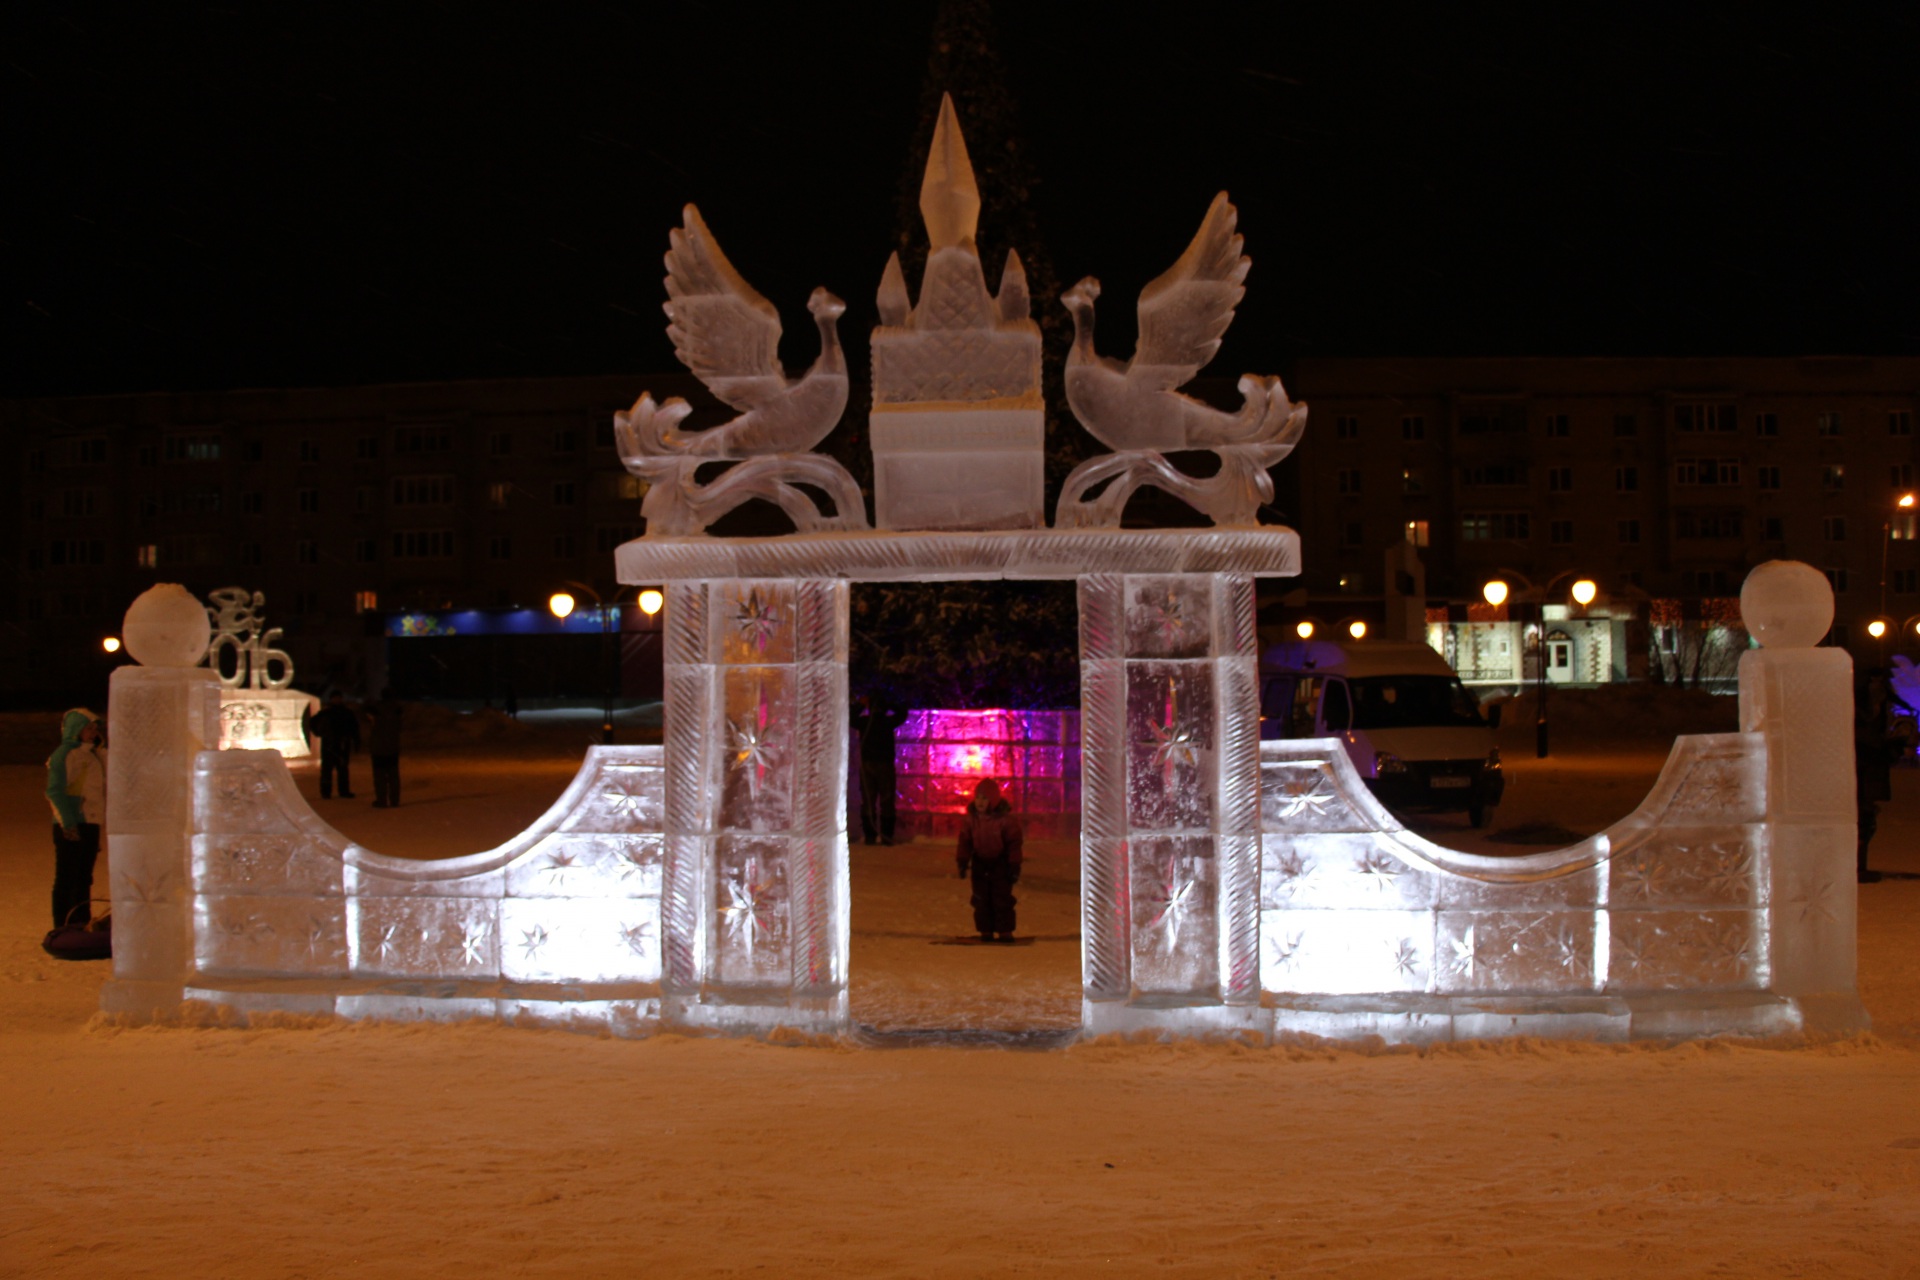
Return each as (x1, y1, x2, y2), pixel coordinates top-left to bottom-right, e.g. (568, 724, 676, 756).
(1260, 641, 1507, 827)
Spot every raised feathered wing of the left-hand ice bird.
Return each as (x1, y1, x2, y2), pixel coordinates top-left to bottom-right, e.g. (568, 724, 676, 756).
(666, 205, 787, 413)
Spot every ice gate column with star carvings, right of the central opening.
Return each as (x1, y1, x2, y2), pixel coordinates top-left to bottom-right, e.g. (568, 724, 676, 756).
(1079, 574, 1260, 1034)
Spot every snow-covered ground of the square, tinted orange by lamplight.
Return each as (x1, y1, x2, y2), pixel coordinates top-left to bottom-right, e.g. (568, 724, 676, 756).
(0, 710, 1920, 1278)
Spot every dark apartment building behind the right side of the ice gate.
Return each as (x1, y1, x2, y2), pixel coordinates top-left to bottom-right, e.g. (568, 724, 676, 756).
(1288, 357, 1920, 649)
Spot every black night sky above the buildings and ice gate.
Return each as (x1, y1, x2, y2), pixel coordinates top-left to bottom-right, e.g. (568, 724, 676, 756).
(0, 0, 1920, 395)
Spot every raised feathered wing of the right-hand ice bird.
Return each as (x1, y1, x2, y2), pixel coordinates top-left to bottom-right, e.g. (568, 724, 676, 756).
(1127, 192, 1252, 391)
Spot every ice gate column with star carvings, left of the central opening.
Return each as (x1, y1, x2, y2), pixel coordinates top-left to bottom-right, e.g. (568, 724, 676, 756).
(662, 580, 847, 1031)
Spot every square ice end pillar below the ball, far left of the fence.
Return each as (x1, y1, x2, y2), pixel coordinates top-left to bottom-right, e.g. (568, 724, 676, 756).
(100, 666, 221, 1017)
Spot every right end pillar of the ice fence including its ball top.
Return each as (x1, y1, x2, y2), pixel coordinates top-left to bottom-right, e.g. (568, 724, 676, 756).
(1740, 560, 1868, 1031)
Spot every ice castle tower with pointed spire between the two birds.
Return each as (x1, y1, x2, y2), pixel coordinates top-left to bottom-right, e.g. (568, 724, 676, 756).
(870, 98, 1046, 530)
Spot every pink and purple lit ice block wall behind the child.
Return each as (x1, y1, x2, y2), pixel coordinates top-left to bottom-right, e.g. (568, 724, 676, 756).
(895, 710, 1081, 841)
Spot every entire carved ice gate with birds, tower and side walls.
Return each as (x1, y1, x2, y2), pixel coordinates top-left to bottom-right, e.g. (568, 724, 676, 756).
(102, 104, 1866, 1042)
